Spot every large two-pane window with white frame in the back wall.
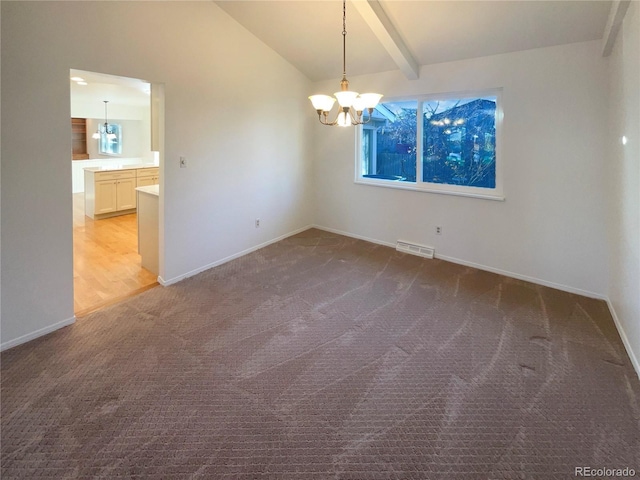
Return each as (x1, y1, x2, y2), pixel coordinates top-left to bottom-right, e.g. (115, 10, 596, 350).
(356, 90, 502, 199)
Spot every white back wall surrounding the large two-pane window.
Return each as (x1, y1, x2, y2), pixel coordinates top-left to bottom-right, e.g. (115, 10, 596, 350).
(314, 42, 608, 296)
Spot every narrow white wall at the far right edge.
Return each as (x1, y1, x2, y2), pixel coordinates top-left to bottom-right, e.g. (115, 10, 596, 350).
(607, 2, 640, 375)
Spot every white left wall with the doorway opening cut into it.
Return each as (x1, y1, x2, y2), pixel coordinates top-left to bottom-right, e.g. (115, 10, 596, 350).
(1, 2, 312, 348)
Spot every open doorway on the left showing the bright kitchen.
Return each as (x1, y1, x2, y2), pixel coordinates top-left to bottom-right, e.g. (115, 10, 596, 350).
(69, 70, 163, 317)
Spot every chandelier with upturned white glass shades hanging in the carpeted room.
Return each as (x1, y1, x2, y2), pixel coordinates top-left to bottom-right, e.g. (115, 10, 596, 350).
(309, 0, 382, 127)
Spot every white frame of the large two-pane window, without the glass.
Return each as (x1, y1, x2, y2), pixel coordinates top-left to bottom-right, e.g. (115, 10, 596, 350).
(354, 88, 504, 201)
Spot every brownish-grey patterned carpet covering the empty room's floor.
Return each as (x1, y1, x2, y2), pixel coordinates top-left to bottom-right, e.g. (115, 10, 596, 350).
(1, 230, 640, 479)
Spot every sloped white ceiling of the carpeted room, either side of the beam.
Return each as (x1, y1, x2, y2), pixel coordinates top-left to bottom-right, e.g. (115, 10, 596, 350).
(216, 0, 612, 81)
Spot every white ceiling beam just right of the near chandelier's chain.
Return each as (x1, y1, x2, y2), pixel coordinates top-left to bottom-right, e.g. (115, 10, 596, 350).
(352, 0, 420, 80)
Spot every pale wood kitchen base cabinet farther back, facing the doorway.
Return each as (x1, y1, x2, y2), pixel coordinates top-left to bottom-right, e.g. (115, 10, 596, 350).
(84, 169, 137, 219)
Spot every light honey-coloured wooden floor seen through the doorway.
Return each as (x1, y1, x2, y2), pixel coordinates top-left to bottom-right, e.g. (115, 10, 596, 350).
(73, 193, 157, 316)
